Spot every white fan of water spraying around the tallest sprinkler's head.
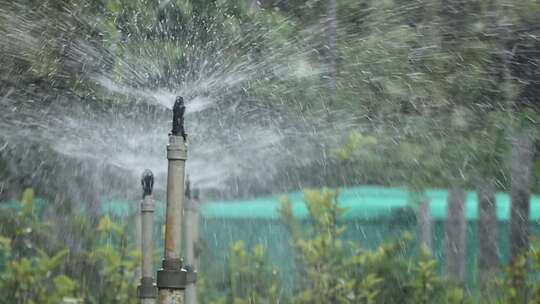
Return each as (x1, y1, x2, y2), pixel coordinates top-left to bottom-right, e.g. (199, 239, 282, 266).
(0, 4, 358, 203)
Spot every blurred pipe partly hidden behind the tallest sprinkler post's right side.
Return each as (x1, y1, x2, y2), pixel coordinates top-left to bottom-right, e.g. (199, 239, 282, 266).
(184, 178, 199, 304)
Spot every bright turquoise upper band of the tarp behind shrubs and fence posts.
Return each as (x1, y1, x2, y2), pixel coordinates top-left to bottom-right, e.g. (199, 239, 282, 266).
(201, 186, 540, 221)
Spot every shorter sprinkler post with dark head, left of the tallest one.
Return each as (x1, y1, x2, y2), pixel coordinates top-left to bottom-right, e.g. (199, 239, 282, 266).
(137, 169, 158, 304)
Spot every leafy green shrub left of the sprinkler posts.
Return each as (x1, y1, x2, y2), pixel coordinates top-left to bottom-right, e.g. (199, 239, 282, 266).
(0, 190, 139, 304)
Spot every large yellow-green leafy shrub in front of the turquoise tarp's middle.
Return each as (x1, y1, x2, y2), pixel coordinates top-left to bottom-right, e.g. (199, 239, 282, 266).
(280, 190, 470, 304)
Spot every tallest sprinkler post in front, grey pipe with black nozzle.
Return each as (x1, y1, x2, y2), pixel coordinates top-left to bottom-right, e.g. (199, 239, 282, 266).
(157, 96, 195, 304)
